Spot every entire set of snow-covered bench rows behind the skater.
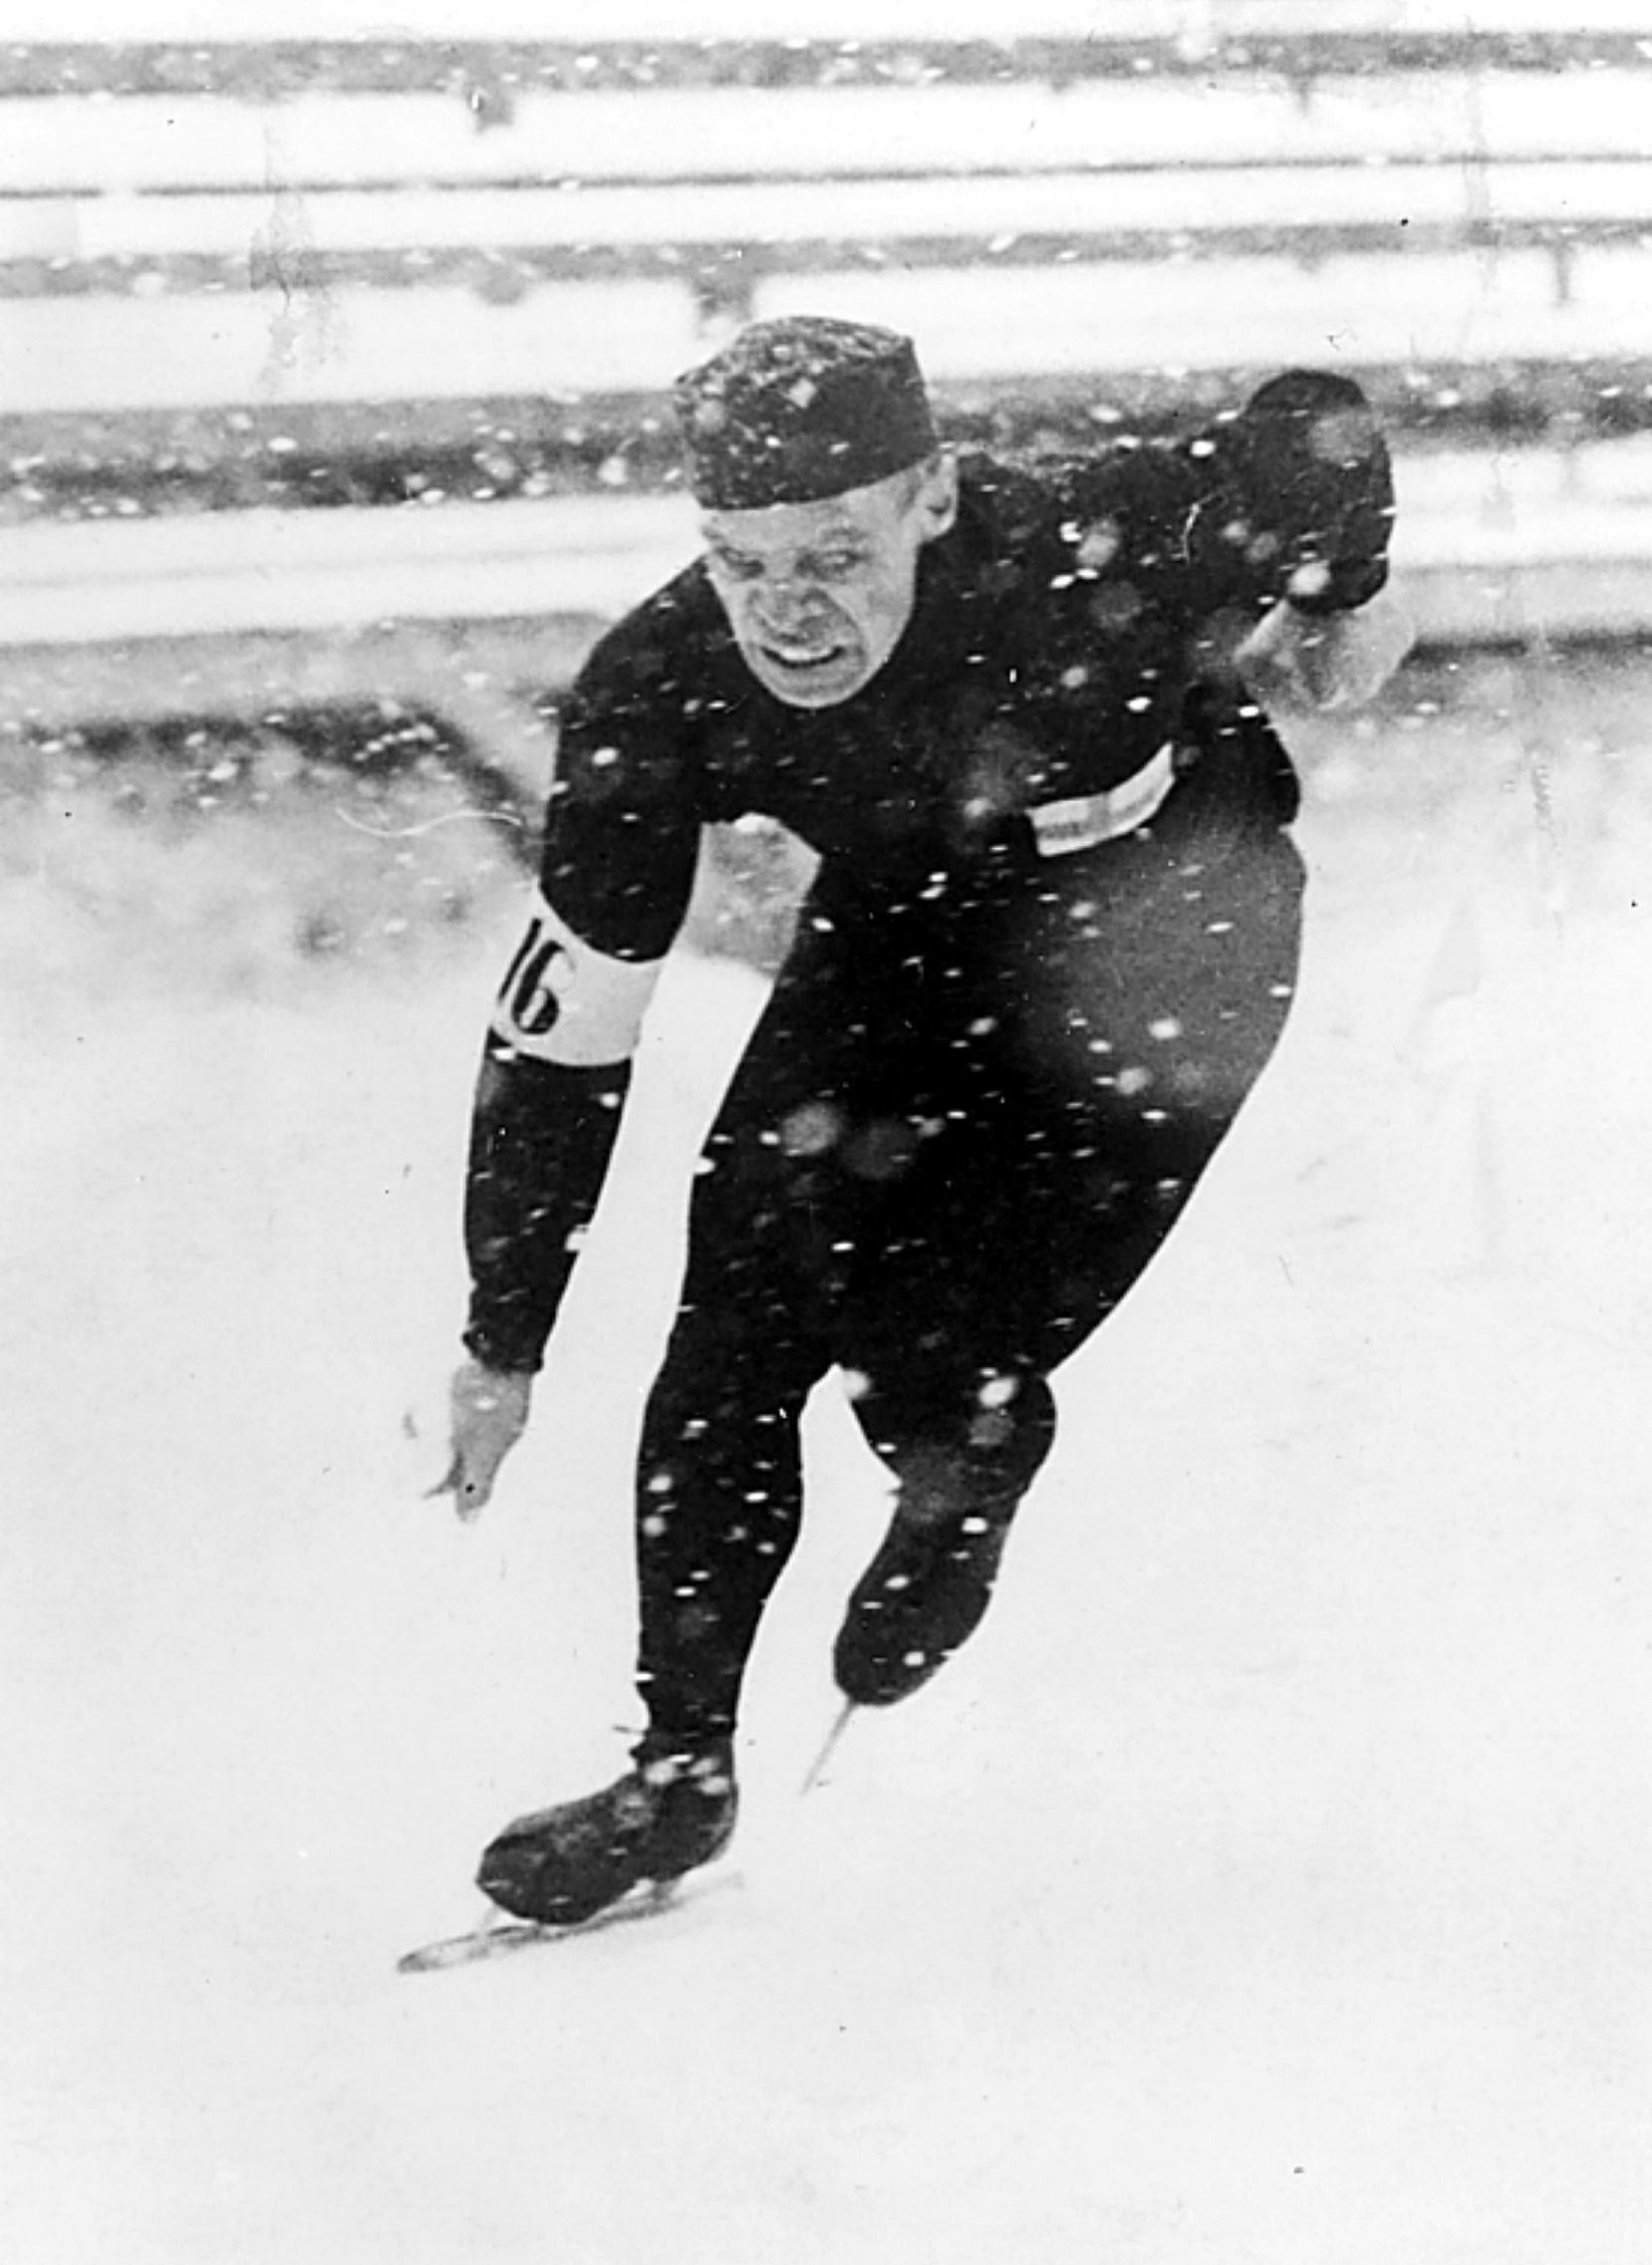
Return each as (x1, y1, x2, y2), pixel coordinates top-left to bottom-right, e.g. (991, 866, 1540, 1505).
(0, 0, 1652, 742)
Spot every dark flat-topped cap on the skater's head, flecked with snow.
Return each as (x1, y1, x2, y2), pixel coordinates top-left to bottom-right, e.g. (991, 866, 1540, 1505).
(673, 315, 939, 512)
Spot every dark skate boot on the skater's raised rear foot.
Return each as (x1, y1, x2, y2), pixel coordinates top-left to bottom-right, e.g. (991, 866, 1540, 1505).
(832, 1504, 1013, 1706)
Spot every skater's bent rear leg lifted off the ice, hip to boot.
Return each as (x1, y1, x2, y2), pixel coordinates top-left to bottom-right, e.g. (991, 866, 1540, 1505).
(836, 836, 1300, 1703)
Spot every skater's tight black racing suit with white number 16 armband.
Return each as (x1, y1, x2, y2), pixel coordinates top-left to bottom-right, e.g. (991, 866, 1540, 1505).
(467, 374, 1391, 1737)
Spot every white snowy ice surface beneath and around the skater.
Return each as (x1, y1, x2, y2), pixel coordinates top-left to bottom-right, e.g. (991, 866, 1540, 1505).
(0, 675, 1652, 2265)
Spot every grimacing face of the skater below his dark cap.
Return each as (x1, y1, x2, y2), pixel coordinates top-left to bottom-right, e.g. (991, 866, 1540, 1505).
(700, 455, 959, 708)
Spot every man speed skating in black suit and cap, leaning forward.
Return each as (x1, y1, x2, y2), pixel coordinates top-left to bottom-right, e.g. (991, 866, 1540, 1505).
(427, 317, 1394, 1925)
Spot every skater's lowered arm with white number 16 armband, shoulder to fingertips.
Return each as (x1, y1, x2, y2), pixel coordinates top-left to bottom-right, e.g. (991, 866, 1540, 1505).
(437, 611, 700, 1518)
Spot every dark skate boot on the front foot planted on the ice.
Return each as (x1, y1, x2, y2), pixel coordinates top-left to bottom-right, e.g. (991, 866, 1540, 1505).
(476, 1735, 738, 1927)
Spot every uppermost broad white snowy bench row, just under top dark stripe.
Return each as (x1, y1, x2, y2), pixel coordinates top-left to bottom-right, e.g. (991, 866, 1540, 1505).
(12, 59, 1647, 199)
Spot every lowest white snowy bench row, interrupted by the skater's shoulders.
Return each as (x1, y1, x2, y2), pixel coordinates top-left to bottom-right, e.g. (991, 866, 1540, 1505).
(0, 441, 1652, 806)
